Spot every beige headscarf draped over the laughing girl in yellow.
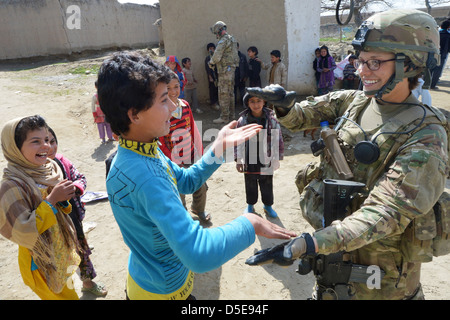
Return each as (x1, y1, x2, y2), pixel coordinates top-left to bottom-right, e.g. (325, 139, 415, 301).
(0, 118, 79, 292)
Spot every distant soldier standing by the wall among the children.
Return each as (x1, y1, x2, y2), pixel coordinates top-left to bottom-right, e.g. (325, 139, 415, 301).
(209, 21, 239, 124)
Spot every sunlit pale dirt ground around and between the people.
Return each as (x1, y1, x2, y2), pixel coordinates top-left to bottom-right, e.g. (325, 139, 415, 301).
(0, 47, 450, 300)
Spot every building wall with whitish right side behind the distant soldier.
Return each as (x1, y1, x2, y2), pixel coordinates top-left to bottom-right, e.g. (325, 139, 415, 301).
(160, 0, 320, 100)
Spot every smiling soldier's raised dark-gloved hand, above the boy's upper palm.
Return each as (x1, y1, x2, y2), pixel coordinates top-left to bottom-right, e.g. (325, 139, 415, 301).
(245, 84, 297, 110)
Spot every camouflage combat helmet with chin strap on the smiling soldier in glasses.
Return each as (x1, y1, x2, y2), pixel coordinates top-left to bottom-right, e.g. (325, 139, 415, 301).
(352, 9, 440, 98)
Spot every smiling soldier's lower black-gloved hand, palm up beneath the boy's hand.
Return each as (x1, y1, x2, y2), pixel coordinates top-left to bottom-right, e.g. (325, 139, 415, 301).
(245, 233, 316, 267)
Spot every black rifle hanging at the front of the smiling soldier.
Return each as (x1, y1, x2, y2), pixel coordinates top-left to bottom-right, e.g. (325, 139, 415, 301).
(297, 179, 385, 300)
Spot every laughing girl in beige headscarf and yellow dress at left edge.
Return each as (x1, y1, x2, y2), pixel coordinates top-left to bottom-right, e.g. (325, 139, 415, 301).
(0, 115, 81, 300)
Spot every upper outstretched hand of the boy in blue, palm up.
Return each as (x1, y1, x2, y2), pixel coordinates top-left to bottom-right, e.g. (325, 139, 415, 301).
(211, 120, 262, 157)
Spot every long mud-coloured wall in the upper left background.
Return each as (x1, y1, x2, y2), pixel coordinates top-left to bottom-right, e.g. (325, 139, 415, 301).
(0, 0, 160, 59)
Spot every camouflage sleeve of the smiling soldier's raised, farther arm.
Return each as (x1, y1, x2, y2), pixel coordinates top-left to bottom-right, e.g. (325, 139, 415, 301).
(277, 90, 360, 132)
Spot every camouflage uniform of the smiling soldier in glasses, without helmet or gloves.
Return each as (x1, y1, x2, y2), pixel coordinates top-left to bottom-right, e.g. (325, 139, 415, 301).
(278, 90, 448, 299)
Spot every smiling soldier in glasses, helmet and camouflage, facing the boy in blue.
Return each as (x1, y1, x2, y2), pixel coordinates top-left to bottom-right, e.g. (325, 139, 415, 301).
(247, 9, 448, 300)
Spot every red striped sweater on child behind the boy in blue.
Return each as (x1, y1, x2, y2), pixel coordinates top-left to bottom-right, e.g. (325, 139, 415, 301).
(159, 99, 203, 166)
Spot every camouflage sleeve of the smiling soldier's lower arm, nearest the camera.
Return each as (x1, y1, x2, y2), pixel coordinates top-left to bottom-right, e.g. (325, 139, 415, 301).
(314, 124, 448, 254)
